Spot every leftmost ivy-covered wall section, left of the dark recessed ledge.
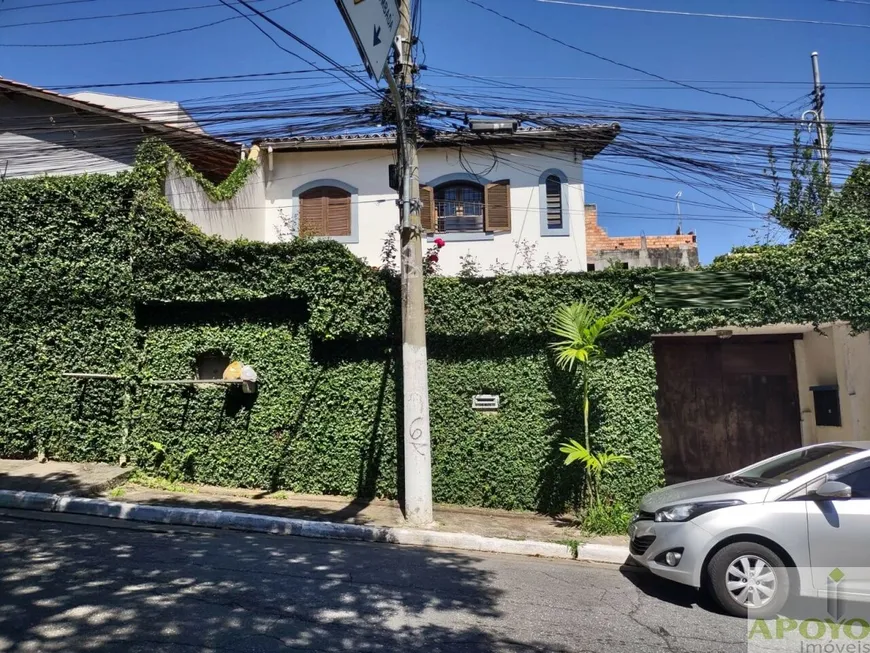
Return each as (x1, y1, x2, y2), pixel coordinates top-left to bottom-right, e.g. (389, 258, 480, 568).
(0, 176, 136, 460)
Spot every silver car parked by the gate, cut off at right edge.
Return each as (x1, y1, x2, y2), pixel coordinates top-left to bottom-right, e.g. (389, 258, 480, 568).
(629, 442, 870, 617)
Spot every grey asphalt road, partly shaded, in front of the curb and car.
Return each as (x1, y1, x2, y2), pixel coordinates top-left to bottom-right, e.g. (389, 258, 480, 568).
(0, 513, 746, 653)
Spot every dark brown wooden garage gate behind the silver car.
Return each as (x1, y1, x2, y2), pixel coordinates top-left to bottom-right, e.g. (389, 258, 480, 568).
(654, 336, 801, 484)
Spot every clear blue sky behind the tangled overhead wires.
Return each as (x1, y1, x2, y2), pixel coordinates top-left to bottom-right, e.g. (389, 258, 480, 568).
(0, 0, 870, 262)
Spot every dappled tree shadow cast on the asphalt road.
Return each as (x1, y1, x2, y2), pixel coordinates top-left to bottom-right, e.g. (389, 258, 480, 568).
(0, 517, 580, 653)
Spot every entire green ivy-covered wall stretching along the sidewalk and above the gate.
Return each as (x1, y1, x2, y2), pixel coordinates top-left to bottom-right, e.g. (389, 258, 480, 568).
(0, 143, 870, 511)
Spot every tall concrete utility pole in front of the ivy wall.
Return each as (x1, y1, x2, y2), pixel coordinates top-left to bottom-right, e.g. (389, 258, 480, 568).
(386, 0, 432, 524)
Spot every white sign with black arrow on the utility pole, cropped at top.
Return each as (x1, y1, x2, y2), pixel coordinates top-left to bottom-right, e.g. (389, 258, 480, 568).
(335, 0, 399, 81)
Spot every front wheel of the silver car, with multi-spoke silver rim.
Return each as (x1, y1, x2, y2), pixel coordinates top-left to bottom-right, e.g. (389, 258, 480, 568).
(707, 542, 791, 619)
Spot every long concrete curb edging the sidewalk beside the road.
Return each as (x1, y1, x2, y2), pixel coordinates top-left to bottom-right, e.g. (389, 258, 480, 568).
(0, 490, 628, 564)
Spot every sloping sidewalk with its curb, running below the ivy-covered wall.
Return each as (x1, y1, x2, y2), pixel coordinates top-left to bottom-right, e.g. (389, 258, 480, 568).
(0, 460, 628, 562)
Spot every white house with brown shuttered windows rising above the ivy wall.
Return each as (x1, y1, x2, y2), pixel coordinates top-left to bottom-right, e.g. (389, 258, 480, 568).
(167, 124, 619, 275)
